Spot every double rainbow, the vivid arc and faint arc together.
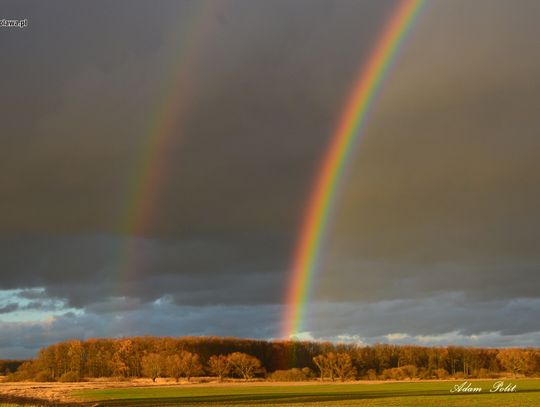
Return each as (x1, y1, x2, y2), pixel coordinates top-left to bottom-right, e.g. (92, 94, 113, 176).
(112, 0, 425, 338)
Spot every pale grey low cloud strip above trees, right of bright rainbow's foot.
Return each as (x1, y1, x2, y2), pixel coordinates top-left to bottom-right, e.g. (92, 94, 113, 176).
(304, 292, 540, 340)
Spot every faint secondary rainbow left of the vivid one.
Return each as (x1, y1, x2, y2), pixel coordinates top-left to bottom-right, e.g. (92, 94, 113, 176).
(114, 0, 216, 297)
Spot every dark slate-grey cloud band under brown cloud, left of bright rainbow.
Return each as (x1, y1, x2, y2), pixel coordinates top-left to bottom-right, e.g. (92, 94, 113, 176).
(0, 235, 289, 308)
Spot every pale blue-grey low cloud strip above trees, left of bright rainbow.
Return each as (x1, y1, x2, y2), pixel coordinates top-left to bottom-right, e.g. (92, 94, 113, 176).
(0, 299, 281, 359)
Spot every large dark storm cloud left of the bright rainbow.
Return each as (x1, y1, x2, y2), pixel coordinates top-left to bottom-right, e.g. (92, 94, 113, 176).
(0, 1, 392, 309)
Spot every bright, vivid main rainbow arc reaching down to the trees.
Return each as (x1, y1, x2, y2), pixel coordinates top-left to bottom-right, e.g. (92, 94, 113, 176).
(282, 0, 425, 338)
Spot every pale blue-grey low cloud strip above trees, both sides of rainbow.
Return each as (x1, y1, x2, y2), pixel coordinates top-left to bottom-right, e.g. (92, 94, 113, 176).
(4, 293, 540, 358)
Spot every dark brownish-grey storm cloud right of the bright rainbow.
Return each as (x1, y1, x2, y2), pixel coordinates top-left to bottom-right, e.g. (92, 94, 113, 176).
(319, 1, 540, 302)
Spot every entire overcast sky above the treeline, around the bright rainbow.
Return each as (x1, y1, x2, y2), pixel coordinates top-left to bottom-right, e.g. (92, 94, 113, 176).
(0, 0, 540, 358)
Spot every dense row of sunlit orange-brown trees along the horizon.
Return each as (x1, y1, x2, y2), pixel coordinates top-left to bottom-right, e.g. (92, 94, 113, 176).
(5, 337, 540, 381)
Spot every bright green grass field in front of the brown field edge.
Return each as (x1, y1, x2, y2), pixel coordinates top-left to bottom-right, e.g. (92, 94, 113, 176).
(73, 380, 540, 407)
